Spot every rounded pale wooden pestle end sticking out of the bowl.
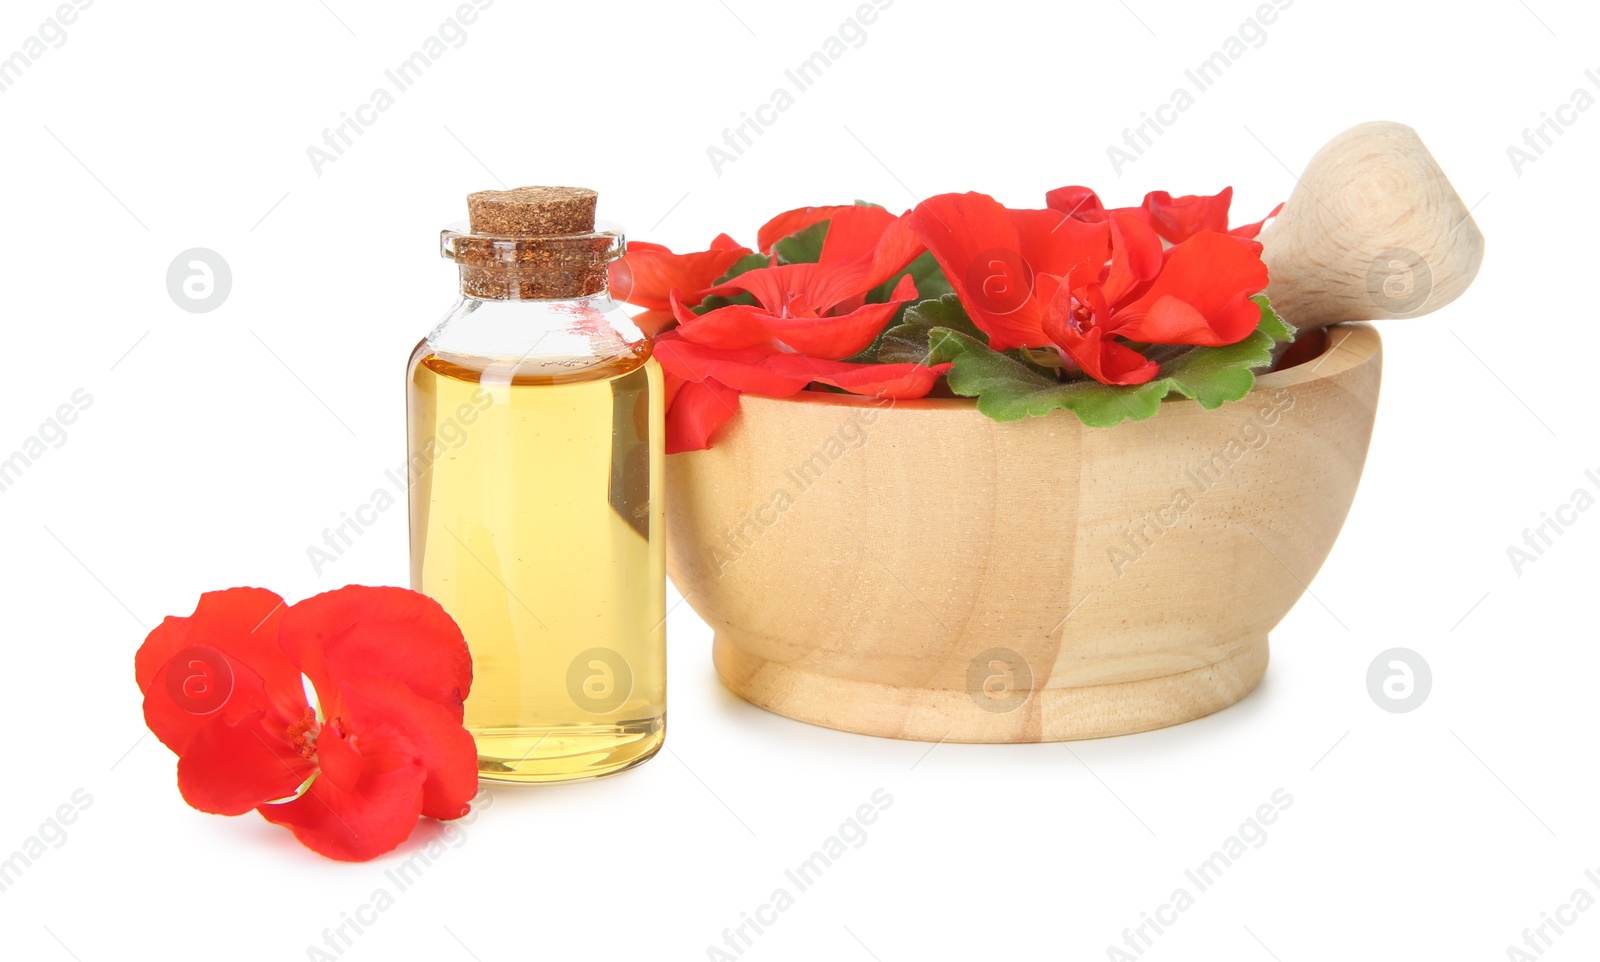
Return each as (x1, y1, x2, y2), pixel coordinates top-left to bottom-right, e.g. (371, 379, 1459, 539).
(1261, 120, 1483, 330)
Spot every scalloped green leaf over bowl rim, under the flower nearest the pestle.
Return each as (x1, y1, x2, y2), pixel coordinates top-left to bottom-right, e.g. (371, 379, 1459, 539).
(918, 296, 1293, 427)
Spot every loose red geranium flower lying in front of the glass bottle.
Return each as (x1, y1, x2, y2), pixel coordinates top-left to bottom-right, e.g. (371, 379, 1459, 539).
(134, 586, 477, 861)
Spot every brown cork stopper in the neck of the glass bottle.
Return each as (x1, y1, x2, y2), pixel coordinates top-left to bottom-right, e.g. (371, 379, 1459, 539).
(440, 187, 624, 301)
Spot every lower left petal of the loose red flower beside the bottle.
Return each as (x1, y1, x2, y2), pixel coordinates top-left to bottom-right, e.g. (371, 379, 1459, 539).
(178, 711, 317, 815)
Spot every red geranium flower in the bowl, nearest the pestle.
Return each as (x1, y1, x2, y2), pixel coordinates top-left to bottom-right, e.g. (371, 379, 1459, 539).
(909, 189, 1267, 384)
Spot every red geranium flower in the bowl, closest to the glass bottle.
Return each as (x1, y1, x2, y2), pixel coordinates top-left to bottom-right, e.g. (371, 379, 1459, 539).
(654, 205, 950, 453)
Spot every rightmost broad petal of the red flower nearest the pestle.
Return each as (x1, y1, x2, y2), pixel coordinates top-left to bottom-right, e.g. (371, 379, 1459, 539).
(1107, 230, 1267, 347)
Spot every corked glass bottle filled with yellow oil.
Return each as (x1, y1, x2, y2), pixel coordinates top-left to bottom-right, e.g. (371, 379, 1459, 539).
(406, 187, 666, 781)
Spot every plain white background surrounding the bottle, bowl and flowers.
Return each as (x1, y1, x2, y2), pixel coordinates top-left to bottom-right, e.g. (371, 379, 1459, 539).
(0, 0, 1600, 962)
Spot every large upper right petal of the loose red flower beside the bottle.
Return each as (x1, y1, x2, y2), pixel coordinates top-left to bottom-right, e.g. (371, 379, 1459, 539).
(278, 584, 472, 717)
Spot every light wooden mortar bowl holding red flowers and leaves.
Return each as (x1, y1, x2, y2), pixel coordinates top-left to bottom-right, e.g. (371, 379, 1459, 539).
(667, 325, 1382, 741)
